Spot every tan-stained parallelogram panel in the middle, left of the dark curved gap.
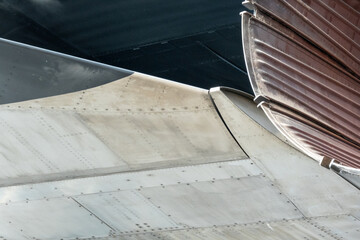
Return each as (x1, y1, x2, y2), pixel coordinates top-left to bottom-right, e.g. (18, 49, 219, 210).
(81, 110, 240, 169)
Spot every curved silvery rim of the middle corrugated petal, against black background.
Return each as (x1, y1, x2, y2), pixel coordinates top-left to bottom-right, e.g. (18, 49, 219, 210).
(240, 11, 261, 97)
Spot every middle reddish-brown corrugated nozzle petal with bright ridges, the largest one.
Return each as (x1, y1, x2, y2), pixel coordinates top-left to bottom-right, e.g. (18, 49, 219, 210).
(243, 14, 360, 145)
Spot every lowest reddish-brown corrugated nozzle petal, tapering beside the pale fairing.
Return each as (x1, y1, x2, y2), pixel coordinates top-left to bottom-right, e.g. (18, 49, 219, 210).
(261, 103, 360, 168)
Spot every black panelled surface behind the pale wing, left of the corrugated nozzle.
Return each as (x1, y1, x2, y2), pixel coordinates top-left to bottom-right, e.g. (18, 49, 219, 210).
(0, 0, 252, 93)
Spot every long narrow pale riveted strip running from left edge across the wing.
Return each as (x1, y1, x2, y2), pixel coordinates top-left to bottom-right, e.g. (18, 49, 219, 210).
(0, 159, 262, 203)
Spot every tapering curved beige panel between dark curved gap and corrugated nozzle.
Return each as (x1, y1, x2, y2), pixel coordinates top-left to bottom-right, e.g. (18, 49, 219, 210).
(210, 88, 360, 217)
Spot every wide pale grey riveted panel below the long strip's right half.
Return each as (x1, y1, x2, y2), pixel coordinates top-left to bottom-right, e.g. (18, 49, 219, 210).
(139, 176, 302, 227)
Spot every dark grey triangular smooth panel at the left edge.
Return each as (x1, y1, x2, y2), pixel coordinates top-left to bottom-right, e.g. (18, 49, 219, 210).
(0, 38, 133, 104)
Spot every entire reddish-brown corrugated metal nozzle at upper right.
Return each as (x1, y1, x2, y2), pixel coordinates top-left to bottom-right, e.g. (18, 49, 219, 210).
(242, 0, 360, 168)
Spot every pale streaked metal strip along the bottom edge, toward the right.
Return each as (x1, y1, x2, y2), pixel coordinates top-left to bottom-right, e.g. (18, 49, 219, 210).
(93, 215, 360, 240)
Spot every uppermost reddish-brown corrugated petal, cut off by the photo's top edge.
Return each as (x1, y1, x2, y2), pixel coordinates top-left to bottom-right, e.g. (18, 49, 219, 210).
(251, 0, 360, 76)
